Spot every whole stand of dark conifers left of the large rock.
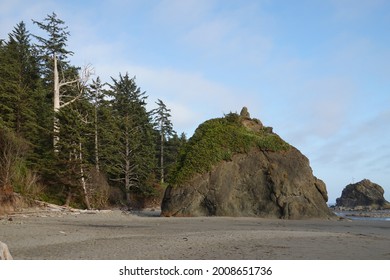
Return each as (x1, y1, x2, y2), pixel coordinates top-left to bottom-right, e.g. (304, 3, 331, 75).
(0, 13, 186, 209)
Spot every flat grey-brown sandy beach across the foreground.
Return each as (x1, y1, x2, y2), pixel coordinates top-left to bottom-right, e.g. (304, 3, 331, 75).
(0, 210, 390, 260)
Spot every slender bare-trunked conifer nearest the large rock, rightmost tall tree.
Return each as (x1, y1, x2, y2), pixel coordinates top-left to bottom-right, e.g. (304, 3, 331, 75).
(153, 99, 175, 184)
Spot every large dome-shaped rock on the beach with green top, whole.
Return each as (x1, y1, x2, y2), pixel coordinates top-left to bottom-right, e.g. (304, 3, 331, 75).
(162, 108, 334, 219)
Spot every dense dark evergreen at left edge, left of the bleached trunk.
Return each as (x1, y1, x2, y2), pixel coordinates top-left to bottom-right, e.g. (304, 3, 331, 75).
(0, 22, 42, 151)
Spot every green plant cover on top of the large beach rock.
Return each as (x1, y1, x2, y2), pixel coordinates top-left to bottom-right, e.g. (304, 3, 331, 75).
(170, 113, 290, 186)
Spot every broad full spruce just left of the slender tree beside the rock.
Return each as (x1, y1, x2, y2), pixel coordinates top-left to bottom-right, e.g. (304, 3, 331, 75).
(110, 73, 155, 206)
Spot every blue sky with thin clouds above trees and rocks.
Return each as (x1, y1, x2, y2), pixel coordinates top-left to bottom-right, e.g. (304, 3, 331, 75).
(0, 0, 390, 203)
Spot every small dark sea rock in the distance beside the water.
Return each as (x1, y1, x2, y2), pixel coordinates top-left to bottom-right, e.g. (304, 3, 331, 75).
(336, 179, 389, 209)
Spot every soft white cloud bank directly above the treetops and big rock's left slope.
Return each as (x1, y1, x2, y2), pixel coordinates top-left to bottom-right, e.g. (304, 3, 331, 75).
(87, 61, 244, 136)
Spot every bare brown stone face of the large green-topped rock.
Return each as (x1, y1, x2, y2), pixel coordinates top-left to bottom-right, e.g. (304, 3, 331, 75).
(162, 110, 334, 219)
